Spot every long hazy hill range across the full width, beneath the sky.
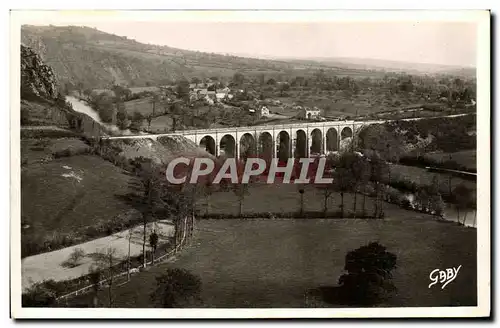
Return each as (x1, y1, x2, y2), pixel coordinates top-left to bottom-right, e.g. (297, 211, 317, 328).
(21, 25, 475, 89)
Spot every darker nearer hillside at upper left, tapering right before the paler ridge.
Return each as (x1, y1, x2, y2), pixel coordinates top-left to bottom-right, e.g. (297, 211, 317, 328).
(21, 26, 304, 88)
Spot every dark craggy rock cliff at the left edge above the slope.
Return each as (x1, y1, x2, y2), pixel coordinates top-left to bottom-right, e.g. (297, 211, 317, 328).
(21, 45, 57, 99)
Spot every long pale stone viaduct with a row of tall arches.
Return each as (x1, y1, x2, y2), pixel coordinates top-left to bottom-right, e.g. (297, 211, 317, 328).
(104, 121, 383, 159)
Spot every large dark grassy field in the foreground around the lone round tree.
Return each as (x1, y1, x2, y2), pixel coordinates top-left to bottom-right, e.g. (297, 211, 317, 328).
(72, 214, 477, 308)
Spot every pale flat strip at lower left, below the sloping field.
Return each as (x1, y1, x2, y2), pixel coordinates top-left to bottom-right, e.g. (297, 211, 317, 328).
(21, 220, 174, 290)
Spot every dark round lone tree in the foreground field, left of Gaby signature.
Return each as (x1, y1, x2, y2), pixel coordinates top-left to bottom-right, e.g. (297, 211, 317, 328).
(339, 242, 397, 306)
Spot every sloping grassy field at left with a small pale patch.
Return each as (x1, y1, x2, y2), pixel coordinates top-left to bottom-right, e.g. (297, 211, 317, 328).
(21, 155, 137, 254)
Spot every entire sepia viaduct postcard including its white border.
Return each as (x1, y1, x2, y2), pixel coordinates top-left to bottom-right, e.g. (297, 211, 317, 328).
(10, 10, 491, 319)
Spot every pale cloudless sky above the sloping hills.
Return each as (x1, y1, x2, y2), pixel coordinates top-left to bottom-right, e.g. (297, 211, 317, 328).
(86, 21, 477, 67)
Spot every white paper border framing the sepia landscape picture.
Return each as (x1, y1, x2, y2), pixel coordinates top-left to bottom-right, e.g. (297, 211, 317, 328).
(10, 10, 491, 319)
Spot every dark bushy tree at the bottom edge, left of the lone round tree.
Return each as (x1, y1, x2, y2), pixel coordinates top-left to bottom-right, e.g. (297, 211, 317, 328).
(150, 268, 201, 308)
